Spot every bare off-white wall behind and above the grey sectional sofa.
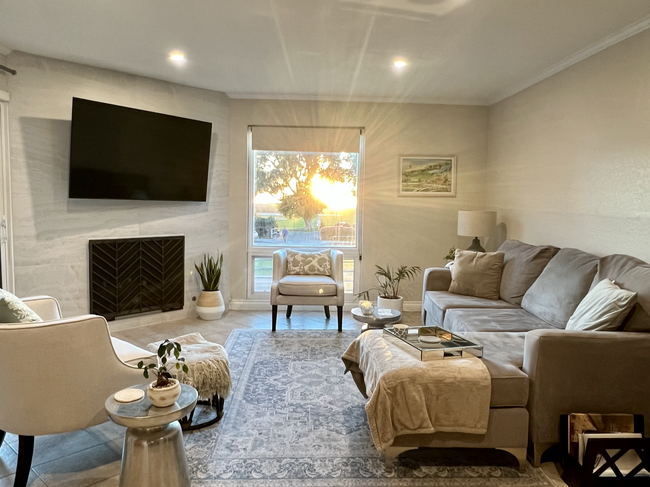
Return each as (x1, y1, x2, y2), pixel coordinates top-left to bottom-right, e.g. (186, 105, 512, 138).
(486, 26, 650, 261)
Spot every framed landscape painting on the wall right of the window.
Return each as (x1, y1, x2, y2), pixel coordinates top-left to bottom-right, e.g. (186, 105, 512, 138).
(399, 156, 456, 196)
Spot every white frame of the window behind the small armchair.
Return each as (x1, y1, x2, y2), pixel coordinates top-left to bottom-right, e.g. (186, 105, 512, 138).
(246, 125, 365, 302)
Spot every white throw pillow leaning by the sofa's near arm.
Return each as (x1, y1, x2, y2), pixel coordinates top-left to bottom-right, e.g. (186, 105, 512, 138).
(566, 279, 636, 331)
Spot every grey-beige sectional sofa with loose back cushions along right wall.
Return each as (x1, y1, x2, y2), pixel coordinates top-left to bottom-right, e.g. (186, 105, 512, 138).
(422, 240, 650, 466)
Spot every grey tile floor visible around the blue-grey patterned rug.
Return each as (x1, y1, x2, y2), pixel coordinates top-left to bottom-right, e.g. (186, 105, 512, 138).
(0, 308, 420, 487)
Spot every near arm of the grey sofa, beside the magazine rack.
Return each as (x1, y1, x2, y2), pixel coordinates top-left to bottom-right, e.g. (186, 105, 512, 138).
(523, 330, 650, 464)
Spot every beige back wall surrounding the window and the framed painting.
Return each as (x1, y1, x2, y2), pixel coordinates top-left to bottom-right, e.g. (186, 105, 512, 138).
(230, 100, 488, 301)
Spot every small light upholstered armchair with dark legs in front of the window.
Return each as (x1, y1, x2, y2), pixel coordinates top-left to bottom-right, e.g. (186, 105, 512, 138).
(271, 249, 345, 331)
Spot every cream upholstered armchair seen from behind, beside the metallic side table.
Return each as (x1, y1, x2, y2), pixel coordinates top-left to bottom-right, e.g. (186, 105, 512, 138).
(0, 296, 155, 487)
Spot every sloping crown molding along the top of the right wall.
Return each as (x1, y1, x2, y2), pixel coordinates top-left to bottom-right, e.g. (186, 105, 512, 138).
(488, 15, 650, 106)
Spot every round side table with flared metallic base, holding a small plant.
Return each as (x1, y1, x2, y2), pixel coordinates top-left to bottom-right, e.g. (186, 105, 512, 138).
(104, 384, 198, 487)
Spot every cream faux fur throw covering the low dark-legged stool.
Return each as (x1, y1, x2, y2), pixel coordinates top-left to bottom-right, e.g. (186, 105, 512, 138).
(147, 333, 231, 399)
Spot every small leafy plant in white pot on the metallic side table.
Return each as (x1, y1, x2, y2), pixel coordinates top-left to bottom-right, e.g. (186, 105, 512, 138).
(138, 340, 189, 408)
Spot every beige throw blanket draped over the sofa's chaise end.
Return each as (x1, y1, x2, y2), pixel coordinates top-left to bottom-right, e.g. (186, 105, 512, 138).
(342, 330, 492, 451)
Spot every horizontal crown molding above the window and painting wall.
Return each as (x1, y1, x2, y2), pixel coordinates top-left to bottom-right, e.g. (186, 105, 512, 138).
(226, 92, 489, 106)
